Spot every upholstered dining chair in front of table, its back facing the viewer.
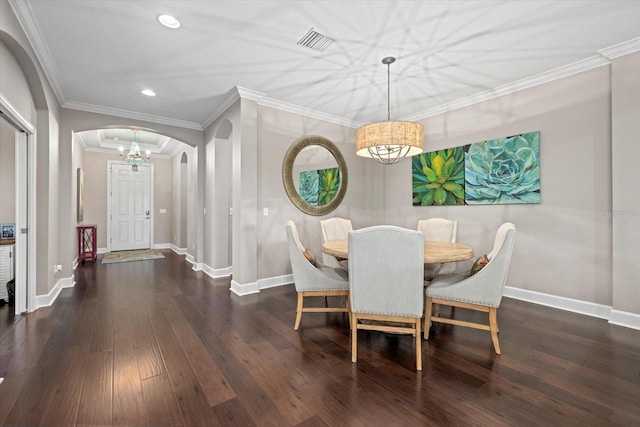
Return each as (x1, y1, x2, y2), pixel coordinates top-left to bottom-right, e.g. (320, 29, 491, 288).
(349, 225, 424, 371)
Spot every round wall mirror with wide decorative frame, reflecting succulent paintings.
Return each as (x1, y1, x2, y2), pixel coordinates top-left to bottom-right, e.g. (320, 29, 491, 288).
(282, 136, 349, 216)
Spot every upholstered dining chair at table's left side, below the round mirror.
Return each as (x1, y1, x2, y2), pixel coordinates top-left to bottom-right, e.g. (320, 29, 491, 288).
(285, 221, 349, 331)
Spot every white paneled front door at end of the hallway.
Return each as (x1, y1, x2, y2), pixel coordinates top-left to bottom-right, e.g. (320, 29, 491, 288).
(110, 163, 153, 251)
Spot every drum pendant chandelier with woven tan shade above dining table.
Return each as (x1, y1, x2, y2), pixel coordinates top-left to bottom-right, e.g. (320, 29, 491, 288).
(356, 56, 424, 165)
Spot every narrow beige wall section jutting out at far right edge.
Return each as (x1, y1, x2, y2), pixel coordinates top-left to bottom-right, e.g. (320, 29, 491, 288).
(609, 53, 640, 315)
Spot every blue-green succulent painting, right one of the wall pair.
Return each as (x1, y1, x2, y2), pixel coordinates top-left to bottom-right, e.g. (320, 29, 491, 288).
(464, 132, 540, 205)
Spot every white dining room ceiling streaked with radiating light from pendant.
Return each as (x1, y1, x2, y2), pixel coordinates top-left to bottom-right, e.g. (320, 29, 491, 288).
(10, 0, 640, 154)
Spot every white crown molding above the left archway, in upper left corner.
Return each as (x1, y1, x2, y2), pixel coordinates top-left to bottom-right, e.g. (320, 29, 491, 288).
(9, 0, 67, 105)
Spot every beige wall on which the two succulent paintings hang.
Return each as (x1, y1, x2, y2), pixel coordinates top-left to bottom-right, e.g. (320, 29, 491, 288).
(385, 66, 612, 306)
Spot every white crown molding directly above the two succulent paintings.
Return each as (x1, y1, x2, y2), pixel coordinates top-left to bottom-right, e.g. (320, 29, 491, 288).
(402, 56, 610, 121)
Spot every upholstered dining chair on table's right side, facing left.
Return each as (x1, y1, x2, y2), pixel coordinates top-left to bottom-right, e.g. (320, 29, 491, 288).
(424, 222, 516, 354)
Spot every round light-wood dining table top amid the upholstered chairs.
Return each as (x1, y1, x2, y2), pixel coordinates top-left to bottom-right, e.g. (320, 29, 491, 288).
(322, 240, 473, 264)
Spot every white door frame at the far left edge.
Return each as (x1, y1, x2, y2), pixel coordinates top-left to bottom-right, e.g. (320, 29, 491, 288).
(0, 93, 38, 314)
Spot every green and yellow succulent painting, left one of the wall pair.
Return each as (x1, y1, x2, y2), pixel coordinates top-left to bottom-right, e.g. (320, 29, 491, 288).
(411, 146, 464, 206)
